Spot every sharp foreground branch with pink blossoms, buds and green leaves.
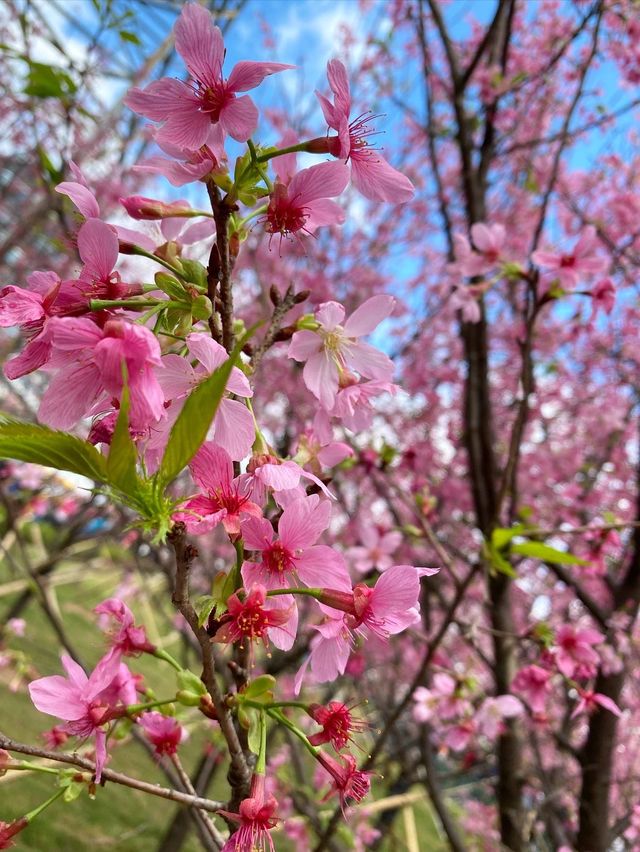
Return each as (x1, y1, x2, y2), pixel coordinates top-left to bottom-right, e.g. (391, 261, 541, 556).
(0, 4, 435, 850)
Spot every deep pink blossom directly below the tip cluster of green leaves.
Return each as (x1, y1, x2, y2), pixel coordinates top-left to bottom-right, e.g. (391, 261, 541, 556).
(175, 441, 262, 537)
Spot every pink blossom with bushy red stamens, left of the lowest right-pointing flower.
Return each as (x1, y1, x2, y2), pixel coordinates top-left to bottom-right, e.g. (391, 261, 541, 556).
(214, 585, 298, 651)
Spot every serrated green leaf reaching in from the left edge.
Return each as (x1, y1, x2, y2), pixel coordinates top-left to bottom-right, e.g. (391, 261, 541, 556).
(0, 415, 108, 482)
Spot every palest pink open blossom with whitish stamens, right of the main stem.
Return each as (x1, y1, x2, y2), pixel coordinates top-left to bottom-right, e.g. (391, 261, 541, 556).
(288, 296, 395, 411)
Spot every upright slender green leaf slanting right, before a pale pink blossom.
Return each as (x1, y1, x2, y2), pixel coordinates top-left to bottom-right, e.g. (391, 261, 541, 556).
(155, 326, 257, 489)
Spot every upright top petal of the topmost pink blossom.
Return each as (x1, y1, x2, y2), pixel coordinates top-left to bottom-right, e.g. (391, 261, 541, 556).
(173, 3, 224, 85)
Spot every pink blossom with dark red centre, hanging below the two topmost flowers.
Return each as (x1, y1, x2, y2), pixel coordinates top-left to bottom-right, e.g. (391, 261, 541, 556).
(265, 158, 349, 243)
